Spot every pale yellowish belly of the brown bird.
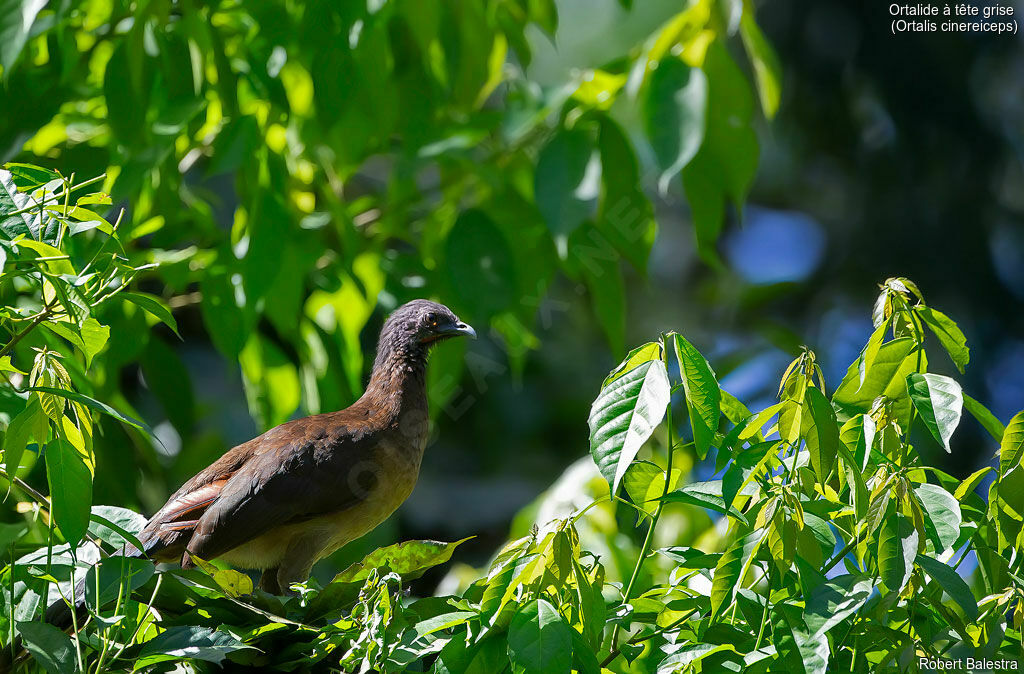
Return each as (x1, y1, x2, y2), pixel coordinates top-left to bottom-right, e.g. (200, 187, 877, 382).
(218, 448, 420, 570)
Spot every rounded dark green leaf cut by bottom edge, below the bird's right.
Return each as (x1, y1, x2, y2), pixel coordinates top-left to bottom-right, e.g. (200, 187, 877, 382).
(508, 599, 572, 674)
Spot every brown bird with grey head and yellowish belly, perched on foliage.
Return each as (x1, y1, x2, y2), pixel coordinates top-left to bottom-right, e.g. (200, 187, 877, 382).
(47, 300, 476, 623)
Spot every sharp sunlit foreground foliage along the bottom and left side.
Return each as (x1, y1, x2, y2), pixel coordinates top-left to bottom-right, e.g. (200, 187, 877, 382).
(0, 178, 1024, 673)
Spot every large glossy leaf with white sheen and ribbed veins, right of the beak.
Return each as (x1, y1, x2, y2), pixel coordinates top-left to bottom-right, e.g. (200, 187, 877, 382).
(590, 361, 670, 493)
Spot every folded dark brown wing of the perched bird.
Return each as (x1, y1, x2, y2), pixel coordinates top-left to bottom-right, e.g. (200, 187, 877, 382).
(184, 418, 380, 559)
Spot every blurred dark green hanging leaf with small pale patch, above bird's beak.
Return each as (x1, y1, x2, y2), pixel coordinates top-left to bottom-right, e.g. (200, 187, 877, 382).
(534, 127, 601, 251)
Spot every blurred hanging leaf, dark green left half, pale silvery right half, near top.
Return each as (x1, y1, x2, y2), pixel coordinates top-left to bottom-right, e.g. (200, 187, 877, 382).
(643, 56, 708, 194)
